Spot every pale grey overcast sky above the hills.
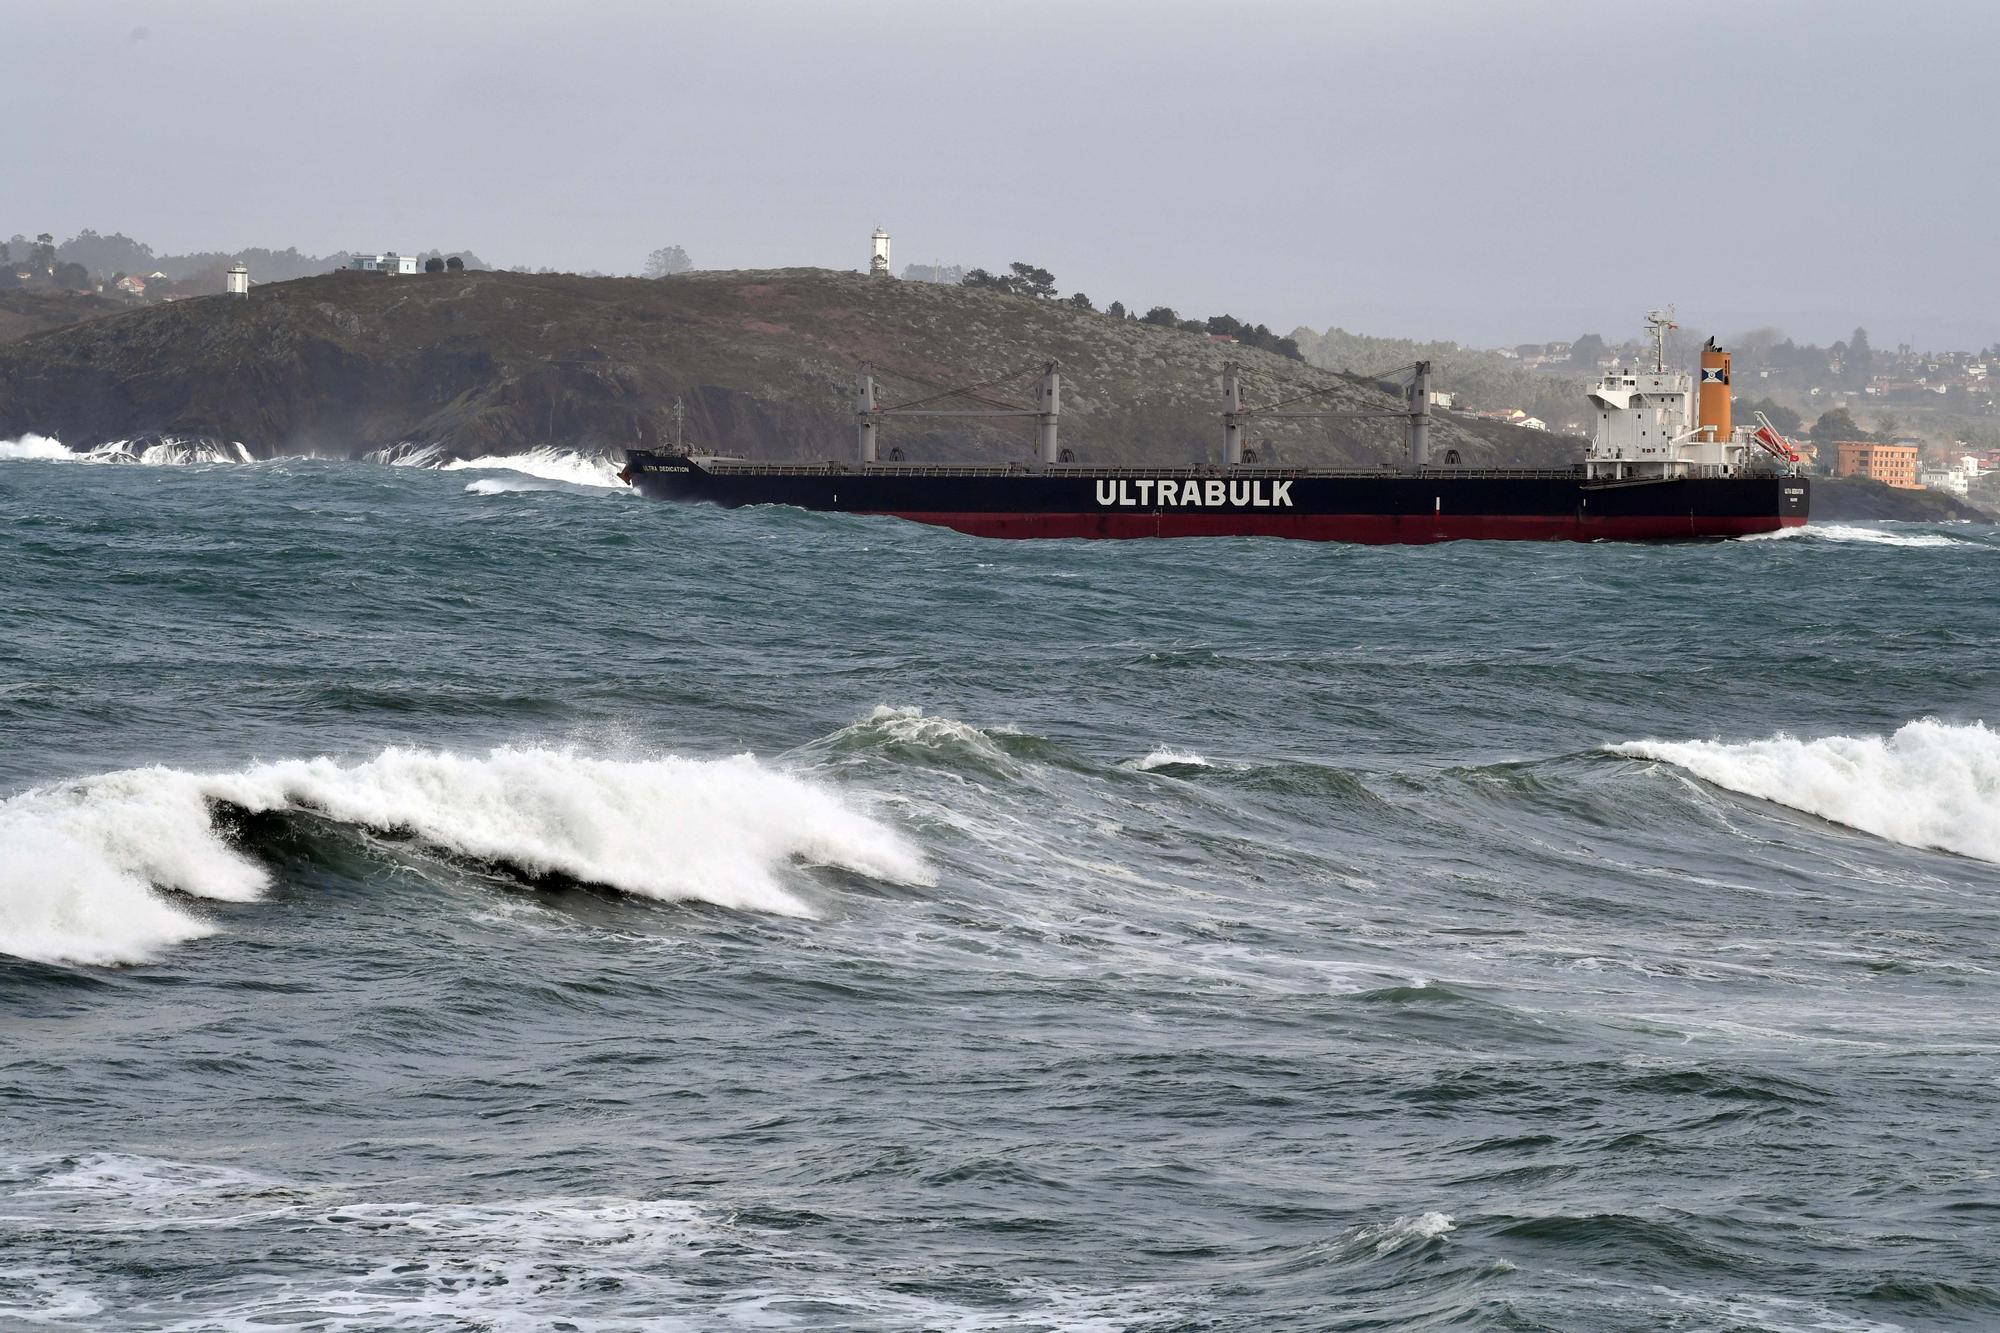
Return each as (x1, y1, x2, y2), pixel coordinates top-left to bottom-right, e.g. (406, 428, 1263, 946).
(0, 0, 2000, 348)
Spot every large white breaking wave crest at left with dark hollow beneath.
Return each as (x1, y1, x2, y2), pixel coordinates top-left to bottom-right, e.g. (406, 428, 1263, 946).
(0, 747, 932, 965)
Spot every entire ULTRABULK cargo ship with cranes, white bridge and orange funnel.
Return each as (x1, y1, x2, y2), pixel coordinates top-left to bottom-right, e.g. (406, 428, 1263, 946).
(620, 312, 1812, 544)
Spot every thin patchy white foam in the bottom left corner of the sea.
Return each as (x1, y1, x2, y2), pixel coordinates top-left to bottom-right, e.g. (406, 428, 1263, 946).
(0, 1153, 1168, 1333)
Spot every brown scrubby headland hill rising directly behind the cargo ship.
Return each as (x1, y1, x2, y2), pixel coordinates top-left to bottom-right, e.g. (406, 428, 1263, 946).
(0, 268, 1574, 464)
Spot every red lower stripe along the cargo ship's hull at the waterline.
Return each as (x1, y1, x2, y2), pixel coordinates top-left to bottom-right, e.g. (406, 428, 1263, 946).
(852, 510, 1806, 546)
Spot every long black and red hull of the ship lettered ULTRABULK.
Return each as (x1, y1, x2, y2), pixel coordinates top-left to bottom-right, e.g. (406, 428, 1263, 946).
(622, 450, 1810, 544)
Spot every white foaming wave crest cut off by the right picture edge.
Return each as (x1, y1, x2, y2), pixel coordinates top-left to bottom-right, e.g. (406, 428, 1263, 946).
(1608, 719, 2000, 861)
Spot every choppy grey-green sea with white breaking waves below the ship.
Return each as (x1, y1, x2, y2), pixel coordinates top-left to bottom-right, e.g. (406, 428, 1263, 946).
(0, 438, 2000, 1333)
